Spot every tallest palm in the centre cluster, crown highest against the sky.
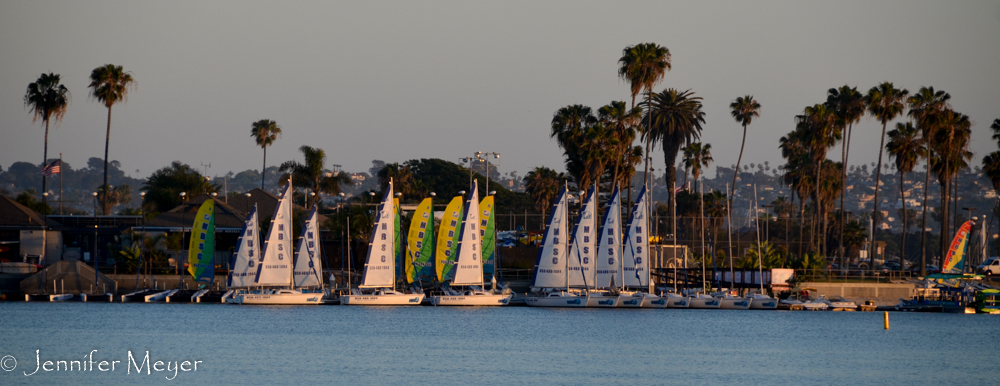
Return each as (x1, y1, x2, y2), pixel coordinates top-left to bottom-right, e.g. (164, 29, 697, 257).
(618, 43, 676, 191)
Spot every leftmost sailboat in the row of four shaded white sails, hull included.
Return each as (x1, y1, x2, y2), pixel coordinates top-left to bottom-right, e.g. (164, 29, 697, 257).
(524, 185, 588, 307)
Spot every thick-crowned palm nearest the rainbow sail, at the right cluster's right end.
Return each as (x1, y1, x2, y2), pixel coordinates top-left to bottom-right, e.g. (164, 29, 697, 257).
(930, 109, 972, 263)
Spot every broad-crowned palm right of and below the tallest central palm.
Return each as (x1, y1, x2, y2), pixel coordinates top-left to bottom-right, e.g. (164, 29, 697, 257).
(644, 88, 705, 246)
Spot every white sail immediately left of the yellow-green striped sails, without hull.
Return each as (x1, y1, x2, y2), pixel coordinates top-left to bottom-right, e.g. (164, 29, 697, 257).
(360, 181, 396, 288)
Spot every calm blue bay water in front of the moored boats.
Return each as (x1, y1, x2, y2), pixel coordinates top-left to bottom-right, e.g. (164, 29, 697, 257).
(0, 302, 1000, 385)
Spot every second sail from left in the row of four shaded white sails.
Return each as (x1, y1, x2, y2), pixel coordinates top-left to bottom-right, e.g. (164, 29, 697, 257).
(566, 185, 597, 288)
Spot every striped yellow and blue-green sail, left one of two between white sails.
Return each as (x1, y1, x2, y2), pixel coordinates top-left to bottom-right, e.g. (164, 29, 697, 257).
(404, 198, 434, 284)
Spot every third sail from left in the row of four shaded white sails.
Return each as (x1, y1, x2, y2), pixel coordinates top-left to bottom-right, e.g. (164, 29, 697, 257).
(593, 186, 622, 288)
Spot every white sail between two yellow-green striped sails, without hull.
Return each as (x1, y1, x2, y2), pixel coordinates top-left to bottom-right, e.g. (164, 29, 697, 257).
(451, 181, 483, 285)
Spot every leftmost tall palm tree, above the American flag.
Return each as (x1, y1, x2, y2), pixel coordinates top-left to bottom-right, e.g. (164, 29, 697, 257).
(24, 72, 69, 204)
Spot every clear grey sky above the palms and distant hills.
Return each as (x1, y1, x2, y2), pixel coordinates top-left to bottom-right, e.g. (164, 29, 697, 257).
(0, 0, 1000, 182)
